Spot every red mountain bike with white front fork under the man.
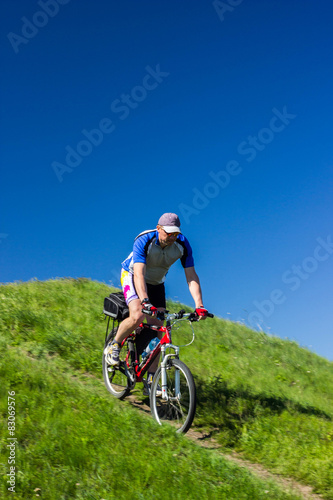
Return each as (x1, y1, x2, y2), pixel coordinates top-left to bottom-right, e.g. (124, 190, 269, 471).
(103, 309, 214, 433)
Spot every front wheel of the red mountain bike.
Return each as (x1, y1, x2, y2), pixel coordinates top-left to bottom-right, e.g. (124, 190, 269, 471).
(150, 358, 196, 433)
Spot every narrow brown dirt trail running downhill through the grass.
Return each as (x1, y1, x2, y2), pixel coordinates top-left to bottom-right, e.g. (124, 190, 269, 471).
(125, 394, 323, 500)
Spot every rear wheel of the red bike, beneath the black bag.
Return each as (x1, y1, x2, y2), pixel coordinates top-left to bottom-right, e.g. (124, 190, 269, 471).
(102, 328, 132, 399)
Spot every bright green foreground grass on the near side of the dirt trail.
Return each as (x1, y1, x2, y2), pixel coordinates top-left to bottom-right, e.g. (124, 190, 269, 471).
(0, 338, 299, 500)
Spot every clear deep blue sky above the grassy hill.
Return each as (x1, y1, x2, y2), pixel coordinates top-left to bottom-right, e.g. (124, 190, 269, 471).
(0, 0, 333, 360)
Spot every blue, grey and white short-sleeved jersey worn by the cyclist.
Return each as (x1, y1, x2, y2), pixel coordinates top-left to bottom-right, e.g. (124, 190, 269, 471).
(121, 229, 194, 285)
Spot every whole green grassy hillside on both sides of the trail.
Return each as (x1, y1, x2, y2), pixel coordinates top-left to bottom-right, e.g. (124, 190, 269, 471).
(0, 279, 333, 500)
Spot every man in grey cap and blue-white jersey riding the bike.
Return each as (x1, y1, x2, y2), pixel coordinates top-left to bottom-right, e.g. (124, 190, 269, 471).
(104, 213, 207, 390)
